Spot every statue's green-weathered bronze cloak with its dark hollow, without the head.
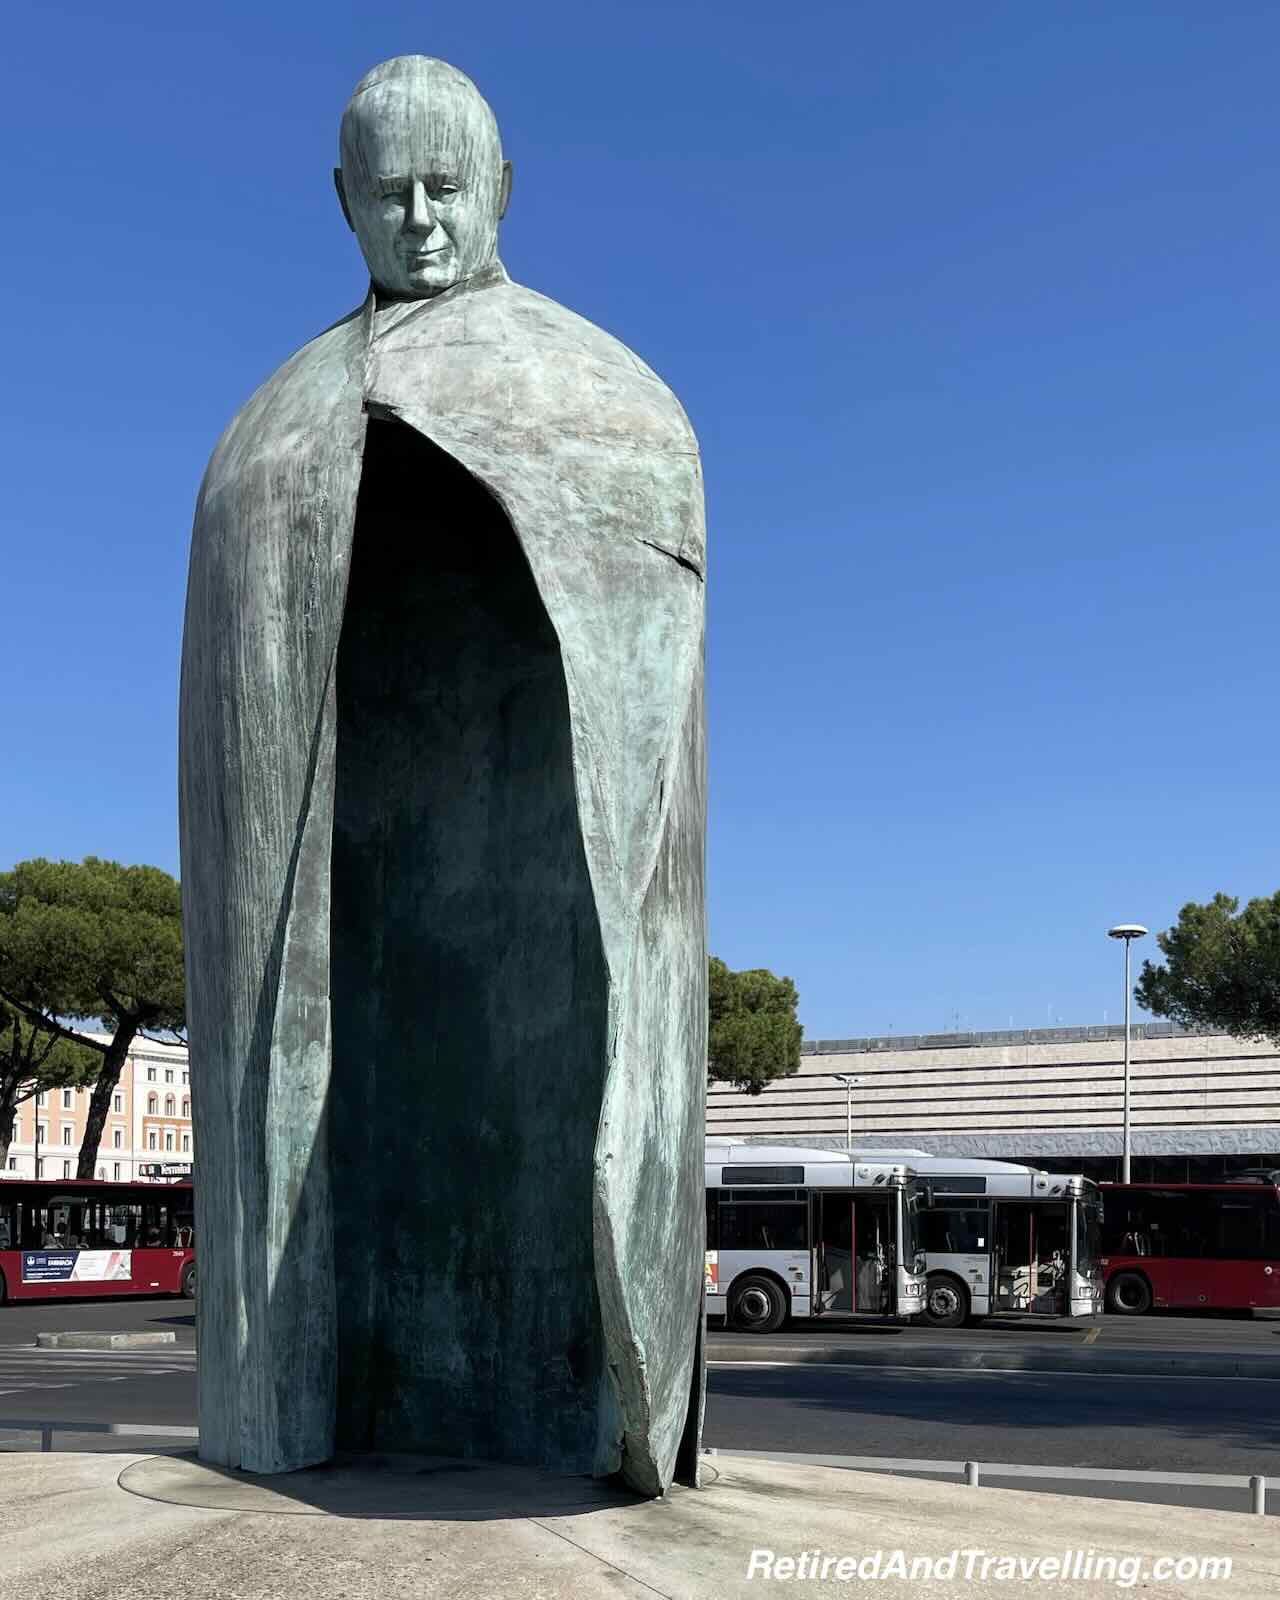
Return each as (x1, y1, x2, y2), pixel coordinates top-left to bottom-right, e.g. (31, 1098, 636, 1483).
(181, 262, 707, 1494)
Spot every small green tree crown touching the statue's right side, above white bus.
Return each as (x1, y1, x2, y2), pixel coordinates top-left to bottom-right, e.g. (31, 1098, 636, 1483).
(707, 955, 803, 1094)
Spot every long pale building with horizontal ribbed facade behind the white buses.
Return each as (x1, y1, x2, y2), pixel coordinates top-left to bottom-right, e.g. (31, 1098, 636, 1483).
(707, 1022, 1280, 1182)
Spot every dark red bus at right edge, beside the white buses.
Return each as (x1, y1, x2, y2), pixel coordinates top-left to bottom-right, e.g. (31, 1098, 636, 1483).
(1099, 1181, 1280, 1317)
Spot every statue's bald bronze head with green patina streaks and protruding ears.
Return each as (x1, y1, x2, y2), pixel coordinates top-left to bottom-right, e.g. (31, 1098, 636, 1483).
(333, 56, 510, 299)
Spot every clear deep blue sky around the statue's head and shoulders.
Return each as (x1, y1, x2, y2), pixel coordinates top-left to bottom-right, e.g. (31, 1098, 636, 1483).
(0, 0, 1280, 1037)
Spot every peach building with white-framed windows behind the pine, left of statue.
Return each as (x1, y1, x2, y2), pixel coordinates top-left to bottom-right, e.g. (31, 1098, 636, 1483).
(0, 1038, 195, 1182)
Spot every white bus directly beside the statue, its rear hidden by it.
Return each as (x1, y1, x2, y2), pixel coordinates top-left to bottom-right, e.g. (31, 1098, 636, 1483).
(706, 1139, 925, 1333)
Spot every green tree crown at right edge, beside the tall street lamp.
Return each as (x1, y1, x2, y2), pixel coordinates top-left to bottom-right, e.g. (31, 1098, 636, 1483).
(1134, 894, 1280, 1043)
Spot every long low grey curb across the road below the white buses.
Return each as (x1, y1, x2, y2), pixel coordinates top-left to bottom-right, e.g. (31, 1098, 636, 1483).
(707, 1342, 1280, 1379)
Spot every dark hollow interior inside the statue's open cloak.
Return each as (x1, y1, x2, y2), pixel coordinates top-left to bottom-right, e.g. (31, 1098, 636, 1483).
(330, 421, 606, 1472)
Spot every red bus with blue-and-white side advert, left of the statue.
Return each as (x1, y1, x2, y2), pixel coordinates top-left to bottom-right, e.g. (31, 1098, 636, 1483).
(0, 1178, 195, 1306)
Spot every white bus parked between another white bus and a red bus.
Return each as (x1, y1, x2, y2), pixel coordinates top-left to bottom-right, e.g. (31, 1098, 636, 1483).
(856, 1150, 1102, 1328)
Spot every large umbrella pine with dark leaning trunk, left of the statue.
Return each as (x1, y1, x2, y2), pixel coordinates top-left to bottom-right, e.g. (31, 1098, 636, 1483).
(0, 856, 186, 1178)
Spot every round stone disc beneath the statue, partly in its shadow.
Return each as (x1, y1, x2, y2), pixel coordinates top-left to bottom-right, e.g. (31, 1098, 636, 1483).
(118, 1454, 684, 1520)
